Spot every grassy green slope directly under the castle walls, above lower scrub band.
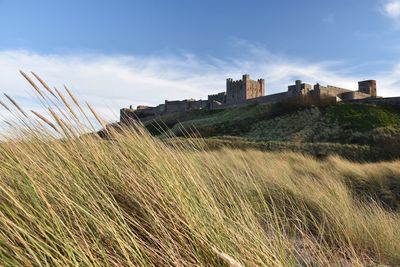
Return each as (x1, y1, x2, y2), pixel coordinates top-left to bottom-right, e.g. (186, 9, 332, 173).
(146, 104, 400, 142)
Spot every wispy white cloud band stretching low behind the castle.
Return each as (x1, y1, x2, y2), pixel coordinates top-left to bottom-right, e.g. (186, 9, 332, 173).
(0, 47, 400, 123)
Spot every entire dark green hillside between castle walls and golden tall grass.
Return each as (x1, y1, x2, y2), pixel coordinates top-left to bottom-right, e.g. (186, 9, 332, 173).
(144, 103, 400, 160)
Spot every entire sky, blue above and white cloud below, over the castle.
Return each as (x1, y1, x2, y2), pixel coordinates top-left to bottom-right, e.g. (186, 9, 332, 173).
(0, 0, 400, 120)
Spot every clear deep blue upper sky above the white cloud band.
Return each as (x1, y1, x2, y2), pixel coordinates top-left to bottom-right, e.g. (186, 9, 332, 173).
(0, 0, 400, 64)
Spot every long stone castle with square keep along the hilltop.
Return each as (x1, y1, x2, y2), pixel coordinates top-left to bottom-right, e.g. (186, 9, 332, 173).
(120, 74, 378, 122)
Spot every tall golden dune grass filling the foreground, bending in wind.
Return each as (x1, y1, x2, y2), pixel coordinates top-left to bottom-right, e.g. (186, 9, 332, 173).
(0, 72, 400, 266)
